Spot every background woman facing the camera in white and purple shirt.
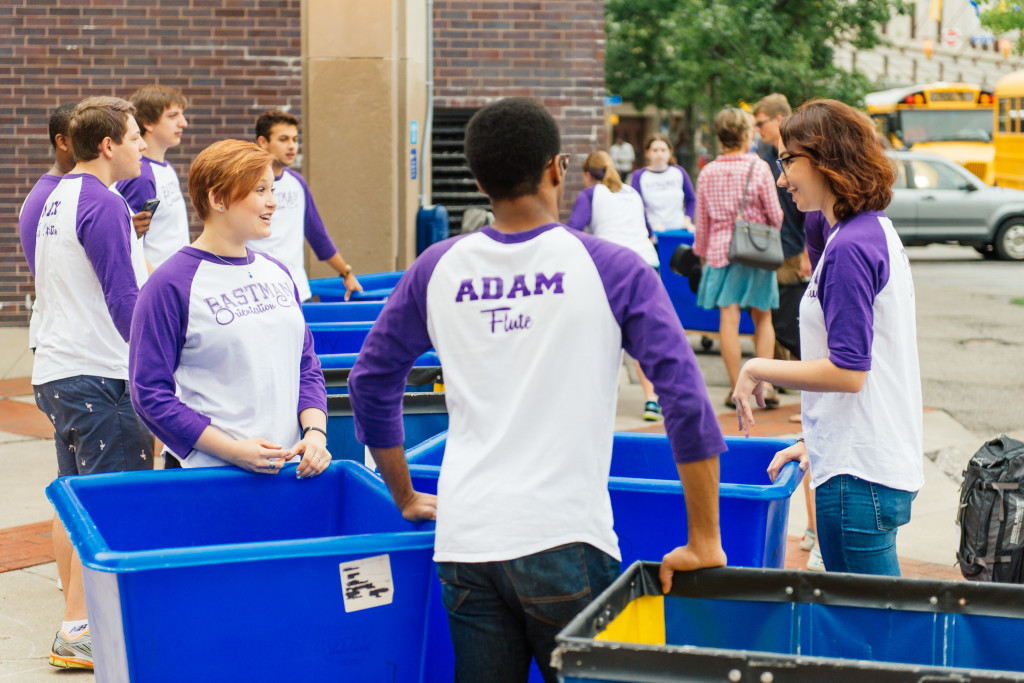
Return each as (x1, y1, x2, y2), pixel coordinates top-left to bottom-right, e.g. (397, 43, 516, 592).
(630, 133, 696, 232)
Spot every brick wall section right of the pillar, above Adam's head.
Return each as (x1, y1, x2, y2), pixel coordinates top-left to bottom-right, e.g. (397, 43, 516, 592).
(434, 0, 607, 211)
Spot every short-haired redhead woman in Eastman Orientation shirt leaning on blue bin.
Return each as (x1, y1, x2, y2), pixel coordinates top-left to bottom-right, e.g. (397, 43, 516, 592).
(129, 140, 331, 479)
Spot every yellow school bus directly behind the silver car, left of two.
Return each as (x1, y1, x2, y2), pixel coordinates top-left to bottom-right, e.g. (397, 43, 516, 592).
(864, 83, 995, 184)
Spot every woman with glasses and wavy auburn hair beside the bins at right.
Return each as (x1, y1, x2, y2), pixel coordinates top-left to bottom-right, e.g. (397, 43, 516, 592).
(733, 99, 924, 577)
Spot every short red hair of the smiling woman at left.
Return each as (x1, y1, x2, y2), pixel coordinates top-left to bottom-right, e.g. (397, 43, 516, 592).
(188, 140, 273, 220)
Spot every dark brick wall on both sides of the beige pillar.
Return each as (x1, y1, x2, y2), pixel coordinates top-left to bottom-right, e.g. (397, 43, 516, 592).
(0, 0, 606, 326)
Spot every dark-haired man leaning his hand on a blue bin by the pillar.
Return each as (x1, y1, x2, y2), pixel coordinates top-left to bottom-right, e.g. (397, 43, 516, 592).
(249, 110, 362, 301)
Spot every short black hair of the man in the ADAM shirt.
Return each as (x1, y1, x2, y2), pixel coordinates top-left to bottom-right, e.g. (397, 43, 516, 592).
(465, 97, 561, 201)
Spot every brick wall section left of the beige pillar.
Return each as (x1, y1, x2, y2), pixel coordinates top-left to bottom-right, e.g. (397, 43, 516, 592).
(0, 0, 302, 326)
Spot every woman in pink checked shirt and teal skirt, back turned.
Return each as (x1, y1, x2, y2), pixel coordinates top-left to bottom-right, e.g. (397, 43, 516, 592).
(693, 104, 782, 408)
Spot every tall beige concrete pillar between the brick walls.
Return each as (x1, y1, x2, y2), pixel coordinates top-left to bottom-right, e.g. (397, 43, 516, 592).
(302, 0, 427, 278)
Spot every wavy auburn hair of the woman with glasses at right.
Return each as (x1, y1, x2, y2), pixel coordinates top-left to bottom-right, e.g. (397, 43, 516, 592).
(779, 99, 896, 220)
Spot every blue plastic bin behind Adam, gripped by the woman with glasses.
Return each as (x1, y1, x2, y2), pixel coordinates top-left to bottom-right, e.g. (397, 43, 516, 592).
(409, 432, 803, 567)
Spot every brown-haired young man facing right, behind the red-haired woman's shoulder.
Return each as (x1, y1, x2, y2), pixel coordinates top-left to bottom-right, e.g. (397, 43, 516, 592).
(117, 85, 191, 268)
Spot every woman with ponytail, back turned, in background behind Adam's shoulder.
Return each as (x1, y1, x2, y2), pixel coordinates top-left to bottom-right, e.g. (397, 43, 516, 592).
(565, 152, 662, 422)
